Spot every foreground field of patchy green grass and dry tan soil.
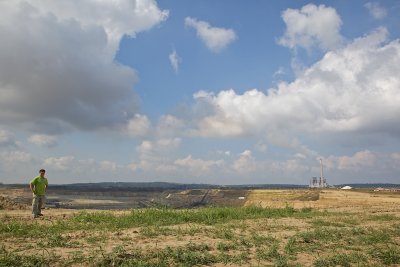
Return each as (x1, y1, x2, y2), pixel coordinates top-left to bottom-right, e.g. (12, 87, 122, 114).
(0, 190, 400, 266)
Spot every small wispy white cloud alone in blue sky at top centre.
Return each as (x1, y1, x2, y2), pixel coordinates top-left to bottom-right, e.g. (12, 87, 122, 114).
(185, 17, 237, 53)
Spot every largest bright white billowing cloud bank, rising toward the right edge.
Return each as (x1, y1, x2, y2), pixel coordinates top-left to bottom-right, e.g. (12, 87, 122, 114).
(192, 28, 400, 142)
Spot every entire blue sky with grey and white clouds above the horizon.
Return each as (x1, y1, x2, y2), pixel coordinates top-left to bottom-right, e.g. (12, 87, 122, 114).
(0, 0, 400, 185)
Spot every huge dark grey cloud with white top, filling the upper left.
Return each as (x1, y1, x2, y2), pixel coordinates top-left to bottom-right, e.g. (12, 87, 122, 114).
(0, 0, 168, 134)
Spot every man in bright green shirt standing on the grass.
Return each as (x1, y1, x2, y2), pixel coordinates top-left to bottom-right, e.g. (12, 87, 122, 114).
(29, 169, 49, 218)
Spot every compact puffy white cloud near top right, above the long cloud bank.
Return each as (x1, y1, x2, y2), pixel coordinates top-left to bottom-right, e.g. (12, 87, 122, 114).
(279, 4, 343, 51)
